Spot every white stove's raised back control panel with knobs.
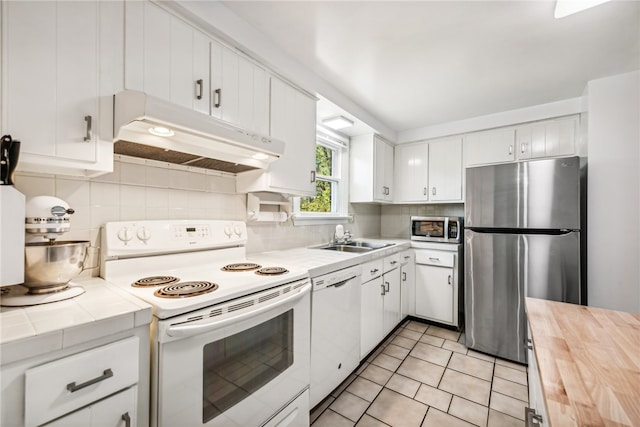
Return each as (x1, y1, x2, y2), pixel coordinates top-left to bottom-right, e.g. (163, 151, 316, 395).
(101, 220, 247, 258)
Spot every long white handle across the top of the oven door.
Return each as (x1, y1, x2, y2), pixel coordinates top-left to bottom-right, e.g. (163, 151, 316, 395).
(166, 283, 311, 338)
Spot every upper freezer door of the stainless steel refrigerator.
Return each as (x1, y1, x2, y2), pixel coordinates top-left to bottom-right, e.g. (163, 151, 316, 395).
(465, 157, 580, 230)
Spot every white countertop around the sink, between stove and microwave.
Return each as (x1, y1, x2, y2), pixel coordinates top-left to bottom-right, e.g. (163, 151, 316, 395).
(247, 239, 411, 277)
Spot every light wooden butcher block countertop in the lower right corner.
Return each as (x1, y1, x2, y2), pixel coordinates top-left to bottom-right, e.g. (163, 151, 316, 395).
(526, 298, 640, 427)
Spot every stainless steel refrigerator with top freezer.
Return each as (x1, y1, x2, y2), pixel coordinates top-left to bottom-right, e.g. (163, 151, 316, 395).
(464, 157, 586, 363)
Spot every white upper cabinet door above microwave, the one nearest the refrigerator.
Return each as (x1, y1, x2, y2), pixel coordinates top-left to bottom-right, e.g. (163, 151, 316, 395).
(429, 137, 462, 201)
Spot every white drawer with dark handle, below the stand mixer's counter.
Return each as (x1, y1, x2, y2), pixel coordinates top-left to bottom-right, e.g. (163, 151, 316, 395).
(25, 337, 140, 427)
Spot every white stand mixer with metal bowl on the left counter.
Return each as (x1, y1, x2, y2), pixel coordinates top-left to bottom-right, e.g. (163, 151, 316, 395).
(0, 196, 90, 307)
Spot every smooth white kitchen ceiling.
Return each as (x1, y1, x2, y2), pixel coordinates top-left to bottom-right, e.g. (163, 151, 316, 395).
(223, 0, 640, 134)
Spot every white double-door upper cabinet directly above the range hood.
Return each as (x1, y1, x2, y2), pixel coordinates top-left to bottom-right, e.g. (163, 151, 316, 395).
(125, 2, 269, 135)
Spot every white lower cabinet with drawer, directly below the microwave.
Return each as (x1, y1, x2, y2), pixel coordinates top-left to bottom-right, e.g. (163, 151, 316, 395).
(415, 249, 460, 327)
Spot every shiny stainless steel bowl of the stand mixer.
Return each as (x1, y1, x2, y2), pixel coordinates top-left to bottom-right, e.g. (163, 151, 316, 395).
(24, 240, 91, 294)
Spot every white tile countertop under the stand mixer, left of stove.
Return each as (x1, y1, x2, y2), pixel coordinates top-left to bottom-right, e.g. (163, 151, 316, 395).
(0, 277, 151, 364)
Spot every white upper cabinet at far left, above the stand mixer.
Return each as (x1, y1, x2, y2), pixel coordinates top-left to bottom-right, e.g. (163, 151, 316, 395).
(2, 1, 124, 176)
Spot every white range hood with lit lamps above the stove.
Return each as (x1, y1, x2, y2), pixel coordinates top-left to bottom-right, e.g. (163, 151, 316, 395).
(113, 90, 284, 173)
